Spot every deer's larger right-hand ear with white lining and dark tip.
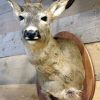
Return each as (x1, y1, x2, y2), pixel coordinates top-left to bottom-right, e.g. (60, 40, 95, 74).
(48, 0, 74, 19)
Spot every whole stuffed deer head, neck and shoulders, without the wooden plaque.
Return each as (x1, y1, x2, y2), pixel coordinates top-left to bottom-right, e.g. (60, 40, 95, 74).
(8, 0, 85, 100)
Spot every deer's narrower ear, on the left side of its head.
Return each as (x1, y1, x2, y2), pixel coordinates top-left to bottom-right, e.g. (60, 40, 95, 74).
(8, 0, 24, 16)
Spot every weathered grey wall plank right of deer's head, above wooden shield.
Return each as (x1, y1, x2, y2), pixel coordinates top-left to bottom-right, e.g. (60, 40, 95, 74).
(53, 9, 100, 43)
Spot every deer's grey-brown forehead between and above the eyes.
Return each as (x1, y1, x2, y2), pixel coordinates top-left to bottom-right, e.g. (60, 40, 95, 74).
(20, 6, 48, 23)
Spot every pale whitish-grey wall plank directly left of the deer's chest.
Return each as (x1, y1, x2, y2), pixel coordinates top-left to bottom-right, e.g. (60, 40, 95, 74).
(0, 55, 36, 85)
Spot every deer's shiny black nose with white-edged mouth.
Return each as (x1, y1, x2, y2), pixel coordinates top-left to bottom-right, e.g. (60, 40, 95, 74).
(24, 30, 41, 40)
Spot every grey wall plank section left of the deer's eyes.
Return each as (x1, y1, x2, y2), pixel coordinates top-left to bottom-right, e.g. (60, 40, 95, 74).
(0, 12, 20, 34)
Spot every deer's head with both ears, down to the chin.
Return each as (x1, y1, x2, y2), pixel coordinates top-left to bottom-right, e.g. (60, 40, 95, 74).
(8, 0, 74, 44)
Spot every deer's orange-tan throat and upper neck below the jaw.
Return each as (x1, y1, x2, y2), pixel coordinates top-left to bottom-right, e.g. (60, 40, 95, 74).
(26, 27, 58, 64)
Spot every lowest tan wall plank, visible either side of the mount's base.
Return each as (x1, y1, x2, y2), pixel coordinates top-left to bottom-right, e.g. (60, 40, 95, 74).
(0, 81, 100, 100)
